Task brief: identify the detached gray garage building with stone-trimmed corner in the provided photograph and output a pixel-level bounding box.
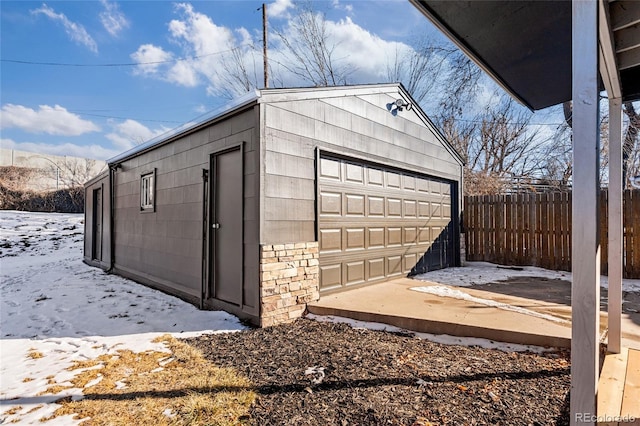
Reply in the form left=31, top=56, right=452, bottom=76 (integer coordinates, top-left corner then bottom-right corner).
left=84, top=84, right=462, bottom=326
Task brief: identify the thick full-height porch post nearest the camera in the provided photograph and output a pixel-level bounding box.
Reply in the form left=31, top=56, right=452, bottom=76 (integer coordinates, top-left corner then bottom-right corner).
left=570, top=0, right=600, bottom=425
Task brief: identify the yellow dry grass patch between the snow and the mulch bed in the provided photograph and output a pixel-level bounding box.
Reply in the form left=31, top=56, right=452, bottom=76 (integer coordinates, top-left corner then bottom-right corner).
left=42, top=336, right=256, bottom=426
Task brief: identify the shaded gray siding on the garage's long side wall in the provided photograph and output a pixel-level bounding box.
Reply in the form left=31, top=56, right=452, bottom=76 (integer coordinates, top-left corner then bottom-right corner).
left=115, top=107, right=259, bottom=317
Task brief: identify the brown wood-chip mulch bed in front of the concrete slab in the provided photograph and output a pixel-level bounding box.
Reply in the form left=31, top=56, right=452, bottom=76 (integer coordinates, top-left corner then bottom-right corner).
left=185, top=319, right=570, bottom=426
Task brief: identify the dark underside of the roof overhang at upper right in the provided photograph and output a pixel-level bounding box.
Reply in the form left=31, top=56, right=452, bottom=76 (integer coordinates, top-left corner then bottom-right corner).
left=409, top=0, right=640, bottom=110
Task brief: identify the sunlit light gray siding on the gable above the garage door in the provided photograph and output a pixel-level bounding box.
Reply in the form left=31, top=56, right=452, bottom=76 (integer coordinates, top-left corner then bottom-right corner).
left=261, top=89, right=462, bottom=244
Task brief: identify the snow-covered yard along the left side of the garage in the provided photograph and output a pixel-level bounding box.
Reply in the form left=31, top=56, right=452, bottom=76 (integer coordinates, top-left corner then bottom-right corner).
left=0, top=211, right=244, bottom=425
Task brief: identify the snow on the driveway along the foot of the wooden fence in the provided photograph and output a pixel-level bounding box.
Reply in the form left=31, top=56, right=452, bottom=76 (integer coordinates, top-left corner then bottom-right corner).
left=413, top=262, right=640, bottom=292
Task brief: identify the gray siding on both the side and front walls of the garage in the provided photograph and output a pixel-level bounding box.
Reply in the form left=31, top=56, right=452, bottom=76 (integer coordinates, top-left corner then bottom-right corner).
left=85, top=85, right=462, bottom=322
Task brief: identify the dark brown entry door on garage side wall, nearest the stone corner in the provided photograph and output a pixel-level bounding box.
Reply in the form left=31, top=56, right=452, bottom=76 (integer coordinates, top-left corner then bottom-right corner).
left=209, top=147, right=243, bottom=305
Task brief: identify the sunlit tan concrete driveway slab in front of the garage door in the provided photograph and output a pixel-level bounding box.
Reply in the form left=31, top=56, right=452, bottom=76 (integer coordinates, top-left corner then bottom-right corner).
left=308, top=277, right=640, bottom=349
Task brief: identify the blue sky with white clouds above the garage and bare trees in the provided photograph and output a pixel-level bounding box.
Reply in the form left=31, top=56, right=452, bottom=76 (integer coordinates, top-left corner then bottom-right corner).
left=0, top=0, right=437, bottom=159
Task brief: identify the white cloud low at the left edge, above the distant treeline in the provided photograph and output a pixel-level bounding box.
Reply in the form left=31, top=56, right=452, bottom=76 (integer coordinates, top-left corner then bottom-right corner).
left=0, top=104, right=100, bottom=136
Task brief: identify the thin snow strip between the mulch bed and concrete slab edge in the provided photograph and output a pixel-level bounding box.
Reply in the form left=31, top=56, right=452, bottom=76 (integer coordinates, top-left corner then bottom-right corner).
left=306, top=314, right=556, bottom=354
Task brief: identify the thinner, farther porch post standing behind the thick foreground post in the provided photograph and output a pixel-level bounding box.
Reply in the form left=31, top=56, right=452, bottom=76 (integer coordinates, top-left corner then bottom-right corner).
left=607, top=98, right=623, bottom=354
